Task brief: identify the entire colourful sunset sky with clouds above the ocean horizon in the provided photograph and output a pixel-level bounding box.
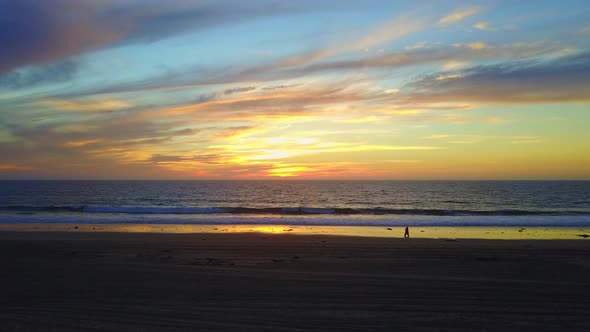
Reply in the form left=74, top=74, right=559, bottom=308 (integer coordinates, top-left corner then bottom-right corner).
left=0, top=0, right=590, bottom=179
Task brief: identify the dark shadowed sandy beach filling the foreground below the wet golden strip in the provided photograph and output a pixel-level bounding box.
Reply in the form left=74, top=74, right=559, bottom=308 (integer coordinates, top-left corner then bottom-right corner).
left=0, top=231, right=590, bottom=331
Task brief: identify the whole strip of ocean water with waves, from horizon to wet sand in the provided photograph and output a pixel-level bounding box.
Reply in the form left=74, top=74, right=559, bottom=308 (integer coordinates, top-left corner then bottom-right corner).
left=0, top=180, right=590, bottom=227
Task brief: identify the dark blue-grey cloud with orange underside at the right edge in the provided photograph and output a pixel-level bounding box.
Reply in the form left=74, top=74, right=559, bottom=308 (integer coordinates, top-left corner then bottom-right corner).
left=406, top=53, right=590, bottom=103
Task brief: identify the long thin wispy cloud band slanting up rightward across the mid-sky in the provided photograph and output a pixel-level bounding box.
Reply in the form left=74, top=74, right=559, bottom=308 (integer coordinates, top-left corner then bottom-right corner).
left=63, top=41, right=567, bottom=95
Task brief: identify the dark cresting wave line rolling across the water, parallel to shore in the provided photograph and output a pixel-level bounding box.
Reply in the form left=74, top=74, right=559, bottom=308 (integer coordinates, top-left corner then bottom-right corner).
left=0, top=205, right=590, bottom=216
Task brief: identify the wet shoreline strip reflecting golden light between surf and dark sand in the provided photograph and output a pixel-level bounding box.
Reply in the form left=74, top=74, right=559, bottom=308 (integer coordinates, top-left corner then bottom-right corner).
left=0, top=223, right=590, bottom=240
